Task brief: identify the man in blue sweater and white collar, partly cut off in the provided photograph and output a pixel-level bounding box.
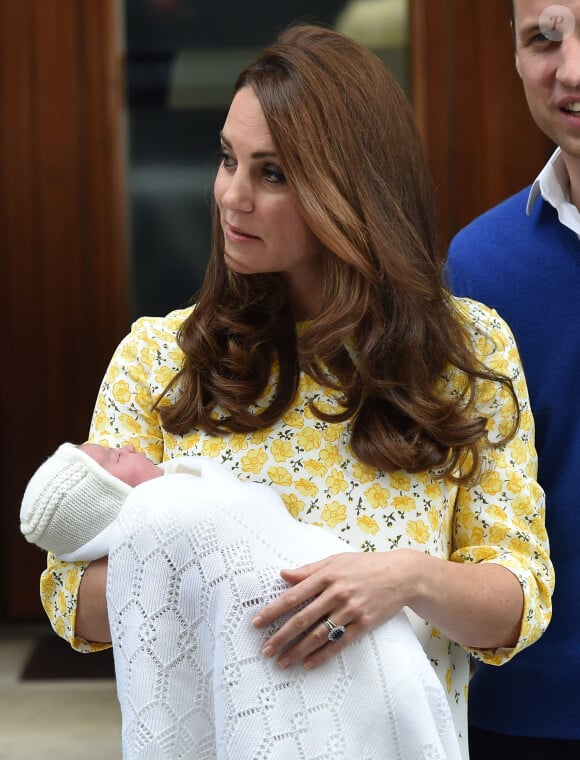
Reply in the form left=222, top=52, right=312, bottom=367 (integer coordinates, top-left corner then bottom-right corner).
left=448, top=0, right=580, bottom=760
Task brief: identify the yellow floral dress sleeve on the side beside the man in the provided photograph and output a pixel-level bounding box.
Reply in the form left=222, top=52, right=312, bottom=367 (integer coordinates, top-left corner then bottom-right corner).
left=451, top=302, right=554, bottom=665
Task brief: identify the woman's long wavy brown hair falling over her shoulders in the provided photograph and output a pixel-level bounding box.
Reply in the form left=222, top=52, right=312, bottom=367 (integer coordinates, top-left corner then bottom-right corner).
left=158, top=26, right=517, bottom=478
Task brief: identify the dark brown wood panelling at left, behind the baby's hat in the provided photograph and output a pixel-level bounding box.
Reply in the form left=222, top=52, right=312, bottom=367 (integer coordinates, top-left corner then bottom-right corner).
left=0, top=0, right=128, bottom=620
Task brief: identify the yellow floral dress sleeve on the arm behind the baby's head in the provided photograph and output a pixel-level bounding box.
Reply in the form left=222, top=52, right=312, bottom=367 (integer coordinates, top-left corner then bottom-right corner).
left=40, top=310, right=188, bottom=652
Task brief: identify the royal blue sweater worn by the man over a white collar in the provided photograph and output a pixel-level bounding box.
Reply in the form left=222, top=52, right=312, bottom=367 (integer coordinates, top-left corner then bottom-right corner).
left=447, top=188, right=580, bottom=739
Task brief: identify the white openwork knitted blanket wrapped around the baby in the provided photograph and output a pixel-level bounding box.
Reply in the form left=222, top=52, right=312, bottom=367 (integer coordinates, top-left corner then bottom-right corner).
left=107, top=460, right=460, bottom=760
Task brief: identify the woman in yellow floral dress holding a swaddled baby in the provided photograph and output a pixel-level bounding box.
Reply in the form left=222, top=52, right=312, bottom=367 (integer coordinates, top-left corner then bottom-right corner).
left=42, top=26, right=553, bottom=760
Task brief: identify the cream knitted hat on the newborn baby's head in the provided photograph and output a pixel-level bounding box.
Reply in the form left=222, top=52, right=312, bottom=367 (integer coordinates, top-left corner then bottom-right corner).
left=20, top=443, right=131, bottom=557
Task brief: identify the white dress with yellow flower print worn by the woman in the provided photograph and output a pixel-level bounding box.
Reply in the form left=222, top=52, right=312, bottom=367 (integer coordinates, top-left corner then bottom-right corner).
left=41, top=299, right=554, bottom=746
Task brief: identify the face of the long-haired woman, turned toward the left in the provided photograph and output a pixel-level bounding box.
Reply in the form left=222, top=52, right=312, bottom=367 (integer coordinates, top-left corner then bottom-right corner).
left=214, top=87, right=320, bottom=309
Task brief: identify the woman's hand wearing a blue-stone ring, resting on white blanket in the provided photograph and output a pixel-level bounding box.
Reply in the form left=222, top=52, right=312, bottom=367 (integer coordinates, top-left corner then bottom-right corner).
left=253, top=550, right=419, bottom=669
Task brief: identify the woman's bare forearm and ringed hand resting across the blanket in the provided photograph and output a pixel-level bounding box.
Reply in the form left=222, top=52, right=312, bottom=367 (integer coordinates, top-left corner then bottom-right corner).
left=253, top=549, right=523, bottom=669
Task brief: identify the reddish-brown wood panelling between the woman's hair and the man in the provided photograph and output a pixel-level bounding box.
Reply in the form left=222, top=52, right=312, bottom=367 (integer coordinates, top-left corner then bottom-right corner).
left=410, top=0, right=553, bottom=246
